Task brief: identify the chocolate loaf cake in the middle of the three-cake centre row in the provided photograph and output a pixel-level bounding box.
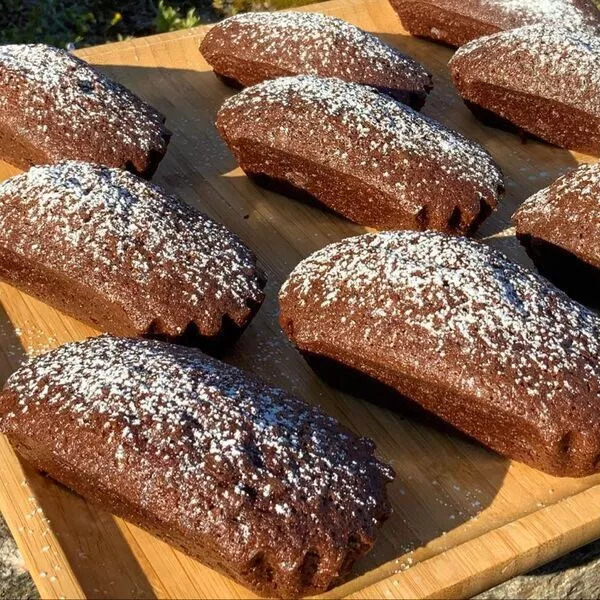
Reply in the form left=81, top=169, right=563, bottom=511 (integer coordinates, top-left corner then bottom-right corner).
left=217, top=75, right=503, bottom=233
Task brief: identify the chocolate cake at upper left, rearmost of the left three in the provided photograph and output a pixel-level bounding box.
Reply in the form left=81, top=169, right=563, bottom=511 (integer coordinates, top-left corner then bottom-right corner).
left=0, top=44, right=171, bottom=177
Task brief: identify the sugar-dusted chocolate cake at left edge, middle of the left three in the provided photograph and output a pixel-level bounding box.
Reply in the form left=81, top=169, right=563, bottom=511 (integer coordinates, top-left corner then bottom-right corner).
left=0, top=162, right=264, bottom=341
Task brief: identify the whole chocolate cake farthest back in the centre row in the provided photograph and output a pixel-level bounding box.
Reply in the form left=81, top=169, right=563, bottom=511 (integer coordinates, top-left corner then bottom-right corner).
left=200, top=11, right=433, bottom=110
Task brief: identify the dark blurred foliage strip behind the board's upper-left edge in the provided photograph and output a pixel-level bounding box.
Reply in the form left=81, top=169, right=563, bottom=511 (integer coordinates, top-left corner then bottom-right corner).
left=0, top=0, right=315, bottom=47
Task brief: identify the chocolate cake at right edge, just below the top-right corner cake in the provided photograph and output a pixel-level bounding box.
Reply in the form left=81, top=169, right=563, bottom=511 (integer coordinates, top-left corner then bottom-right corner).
left=450, top=25, right=600, bottom=154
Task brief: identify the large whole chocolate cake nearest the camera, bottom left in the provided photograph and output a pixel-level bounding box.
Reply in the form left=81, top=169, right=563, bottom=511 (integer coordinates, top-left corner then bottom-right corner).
left=0, top=336, right=393, bottom=598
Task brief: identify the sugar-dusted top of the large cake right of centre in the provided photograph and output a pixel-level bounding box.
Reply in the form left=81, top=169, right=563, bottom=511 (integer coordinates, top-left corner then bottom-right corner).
left=281, top=232, right=600, bottom=426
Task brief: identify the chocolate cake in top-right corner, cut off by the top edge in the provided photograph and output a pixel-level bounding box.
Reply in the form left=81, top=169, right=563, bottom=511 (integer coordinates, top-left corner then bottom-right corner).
left=390, top=0, right=600, bottom=46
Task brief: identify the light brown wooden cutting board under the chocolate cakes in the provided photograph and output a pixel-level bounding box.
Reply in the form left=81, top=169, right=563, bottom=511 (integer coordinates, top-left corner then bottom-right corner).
left=0, top=0, right=600, bottom=598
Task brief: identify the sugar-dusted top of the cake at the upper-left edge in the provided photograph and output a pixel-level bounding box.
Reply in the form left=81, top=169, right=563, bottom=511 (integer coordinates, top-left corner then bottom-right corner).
left=0, top=44, right=168, bottom=160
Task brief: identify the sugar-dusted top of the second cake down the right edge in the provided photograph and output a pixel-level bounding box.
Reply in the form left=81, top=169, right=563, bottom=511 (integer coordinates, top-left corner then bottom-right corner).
left=450, top=25, right=600, bottom=116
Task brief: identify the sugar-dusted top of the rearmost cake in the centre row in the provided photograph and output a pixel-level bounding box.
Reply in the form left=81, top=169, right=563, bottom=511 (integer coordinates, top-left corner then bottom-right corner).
left=209, top=11, right=431, bottom=88
